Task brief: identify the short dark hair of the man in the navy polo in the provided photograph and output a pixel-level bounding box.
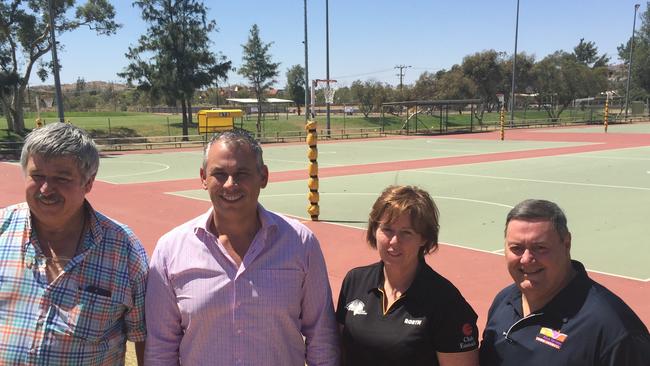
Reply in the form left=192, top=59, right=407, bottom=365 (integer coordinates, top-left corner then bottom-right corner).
left=506, top=199, right=570, bottom=240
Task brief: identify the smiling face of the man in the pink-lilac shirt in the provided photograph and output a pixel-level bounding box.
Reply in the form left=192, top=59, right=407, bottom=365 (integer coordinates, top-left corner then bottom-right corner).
left=201, top=141, right=269, bottom=224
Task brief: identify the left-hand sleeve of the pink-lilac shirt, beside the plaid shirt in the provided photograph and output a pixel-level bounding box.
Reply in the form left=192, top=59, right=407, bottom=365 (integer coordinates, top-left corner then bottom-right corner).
left=145, top=241, right=183, bottom=365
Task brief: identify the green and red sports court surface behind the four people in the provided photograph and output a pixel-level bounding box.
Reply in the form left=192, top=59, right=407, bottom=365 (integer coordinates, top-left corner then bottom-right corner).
left=0, top=123, right=650, bottom=329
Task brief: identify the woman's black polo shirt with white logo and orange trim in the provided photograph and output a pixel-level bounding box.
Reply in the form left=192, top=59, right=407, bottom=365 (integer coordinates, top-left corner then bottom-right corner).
left=336, top=260, right=478, bottom=366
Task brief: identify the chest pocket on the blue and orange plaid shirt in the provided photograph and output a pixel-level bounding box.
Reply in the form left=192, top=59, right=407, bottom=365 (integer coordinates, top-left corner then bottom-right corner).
left=55, top=289, right=120, bottom=342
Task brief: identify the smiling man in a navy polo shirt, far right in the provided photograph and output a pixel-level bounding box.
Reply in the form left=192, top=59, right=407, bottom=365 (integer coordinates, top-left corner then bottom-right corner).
left=480, top=200, right=650, bottom=366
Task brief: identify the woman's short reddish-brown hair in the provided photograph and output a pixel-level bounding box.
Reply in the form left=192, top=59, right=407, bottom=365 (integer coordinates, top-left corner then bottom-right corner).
left=366, top=186, right=440, bottom=256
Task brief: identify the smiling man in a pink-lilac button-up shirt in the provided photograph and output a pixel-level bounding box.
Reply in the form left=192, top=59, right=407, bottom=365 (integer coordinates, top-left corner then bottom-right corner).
left=145, top=130, right=339, bottom=366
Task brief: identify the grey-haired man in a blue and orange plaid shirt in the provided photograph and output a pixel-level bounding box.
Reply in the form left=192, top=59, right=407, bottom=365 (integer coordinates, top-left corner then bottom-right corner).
left=0, top=122, right=148, bottom=365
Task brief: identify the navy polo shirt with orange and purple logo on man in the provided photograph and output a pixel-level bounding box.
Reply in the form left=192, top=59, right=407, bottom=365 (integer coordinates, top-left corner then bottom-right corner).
left=480, top=261, right=650, bottom=366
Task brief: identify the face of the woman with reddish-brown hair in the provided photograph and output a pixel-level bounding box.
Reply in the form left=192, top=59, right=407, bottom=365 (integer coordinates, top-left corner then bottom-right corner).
left=375, top=212, right=425, bottom=269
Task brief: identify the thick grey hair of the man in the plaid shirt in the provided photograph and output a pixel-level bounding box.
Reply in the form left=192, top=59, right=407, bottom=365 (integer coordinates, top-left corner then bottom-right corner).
left=20, top=122, right=99, bottom=183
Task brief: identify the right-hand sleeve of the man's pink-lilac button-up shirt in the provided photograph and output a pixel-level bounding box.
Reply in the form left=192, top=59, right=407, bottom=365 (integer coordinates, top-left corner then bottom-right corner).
left=301, top=234, right=339, bottom=366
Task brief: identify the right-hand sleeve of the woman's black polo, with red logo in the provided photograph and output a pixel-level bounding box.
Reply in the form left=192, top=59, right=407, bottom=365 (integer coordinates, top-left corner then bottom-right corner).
left=432, top=288, right=478, bottom=353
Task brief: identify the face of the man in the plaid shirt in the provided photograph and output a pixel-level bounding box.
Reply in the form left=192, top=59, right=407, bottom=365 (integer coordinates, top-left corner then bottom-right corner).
left=25, top=154, right=94, bottom=228
